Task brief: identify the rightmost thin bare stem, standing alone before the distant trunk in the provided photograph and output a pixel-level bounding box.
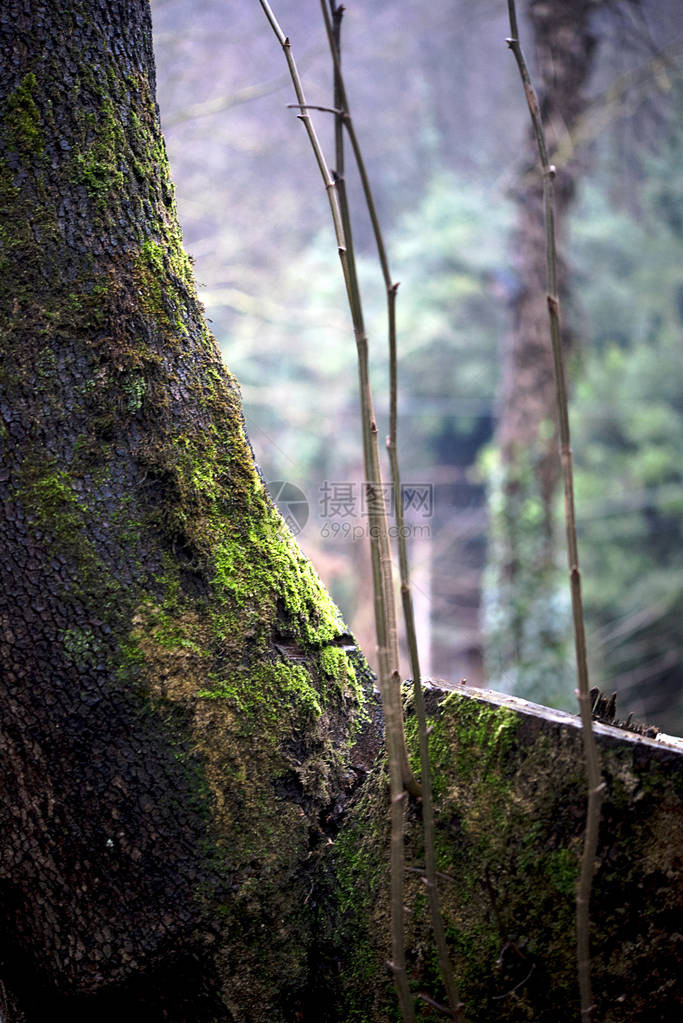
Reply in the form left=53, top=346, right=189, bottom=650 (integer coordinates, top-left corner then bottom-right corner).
left=506, top=0, right=604, bottom=1020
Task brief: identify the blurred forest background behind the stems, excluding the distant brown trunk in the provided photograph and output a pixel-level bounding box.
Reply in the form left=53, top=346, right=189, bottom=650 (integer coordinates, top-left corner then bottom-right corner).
left=152, top=0, right=683, bottom=732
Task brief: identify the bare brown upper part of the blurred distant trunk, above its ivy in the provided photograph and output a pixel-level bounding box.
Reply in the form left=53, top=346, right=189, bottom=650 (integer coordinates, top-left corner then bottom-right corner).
left=498, top=0, right=597, bottom=486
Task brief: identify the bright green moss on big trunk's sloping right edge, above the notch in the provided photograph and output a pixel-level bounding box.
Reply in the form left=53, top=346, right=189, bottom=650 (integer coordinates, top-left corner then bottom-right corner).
left=144, top=405, right=353, bottom=646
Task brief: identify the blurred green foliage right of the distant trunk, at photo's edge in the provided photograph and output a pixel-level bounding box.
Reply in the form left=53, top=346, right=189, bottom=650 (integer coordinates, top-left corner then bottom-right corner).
left=571, top=119, right=683, bottom=731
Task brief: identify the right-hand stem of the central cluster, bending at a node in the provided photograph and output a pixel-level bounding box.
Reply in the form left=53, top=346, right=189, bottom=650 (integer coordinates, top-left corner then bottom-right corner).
left=320, top=0, right=464, bottom=1021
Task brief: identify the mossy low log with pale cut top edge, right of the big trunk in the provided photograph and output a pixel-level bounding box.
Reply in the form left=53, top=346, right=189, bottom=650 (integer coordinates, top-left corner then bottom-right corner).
left=319, top=685, right=683, bottom=1023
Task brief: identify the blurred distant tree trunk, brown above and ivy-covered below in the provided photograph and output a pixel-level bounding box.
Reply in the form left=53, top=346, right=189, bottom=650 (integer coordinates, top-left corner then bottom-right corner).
left=488, top=0, right=598, bottom=702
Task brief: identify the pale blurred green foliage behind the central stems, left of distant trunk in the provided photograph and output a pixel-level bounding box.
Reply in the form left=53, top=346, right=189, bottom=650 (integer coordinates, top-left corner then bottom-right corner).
left=221, top=174, right=511, bottom=484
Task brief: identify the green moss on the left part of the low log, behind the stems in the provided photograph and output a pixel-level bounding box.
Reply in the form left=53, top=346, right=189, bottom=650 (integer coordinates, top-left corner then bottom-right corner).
left=327, top=693, right=573, bottom=1023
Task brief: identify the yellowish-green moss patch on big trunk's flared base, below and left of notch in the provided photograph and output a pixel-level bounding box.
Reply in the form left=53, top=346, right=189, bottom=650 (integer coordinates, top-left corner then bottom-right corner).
left=124, top=577, right=361, bottom=822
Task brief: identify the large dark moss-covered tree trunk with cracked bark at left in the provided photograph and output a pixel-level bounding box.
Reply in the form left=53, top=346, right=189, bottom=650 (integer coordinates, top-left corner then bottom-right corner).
left=0, top=0, right=376, bottom=1023
